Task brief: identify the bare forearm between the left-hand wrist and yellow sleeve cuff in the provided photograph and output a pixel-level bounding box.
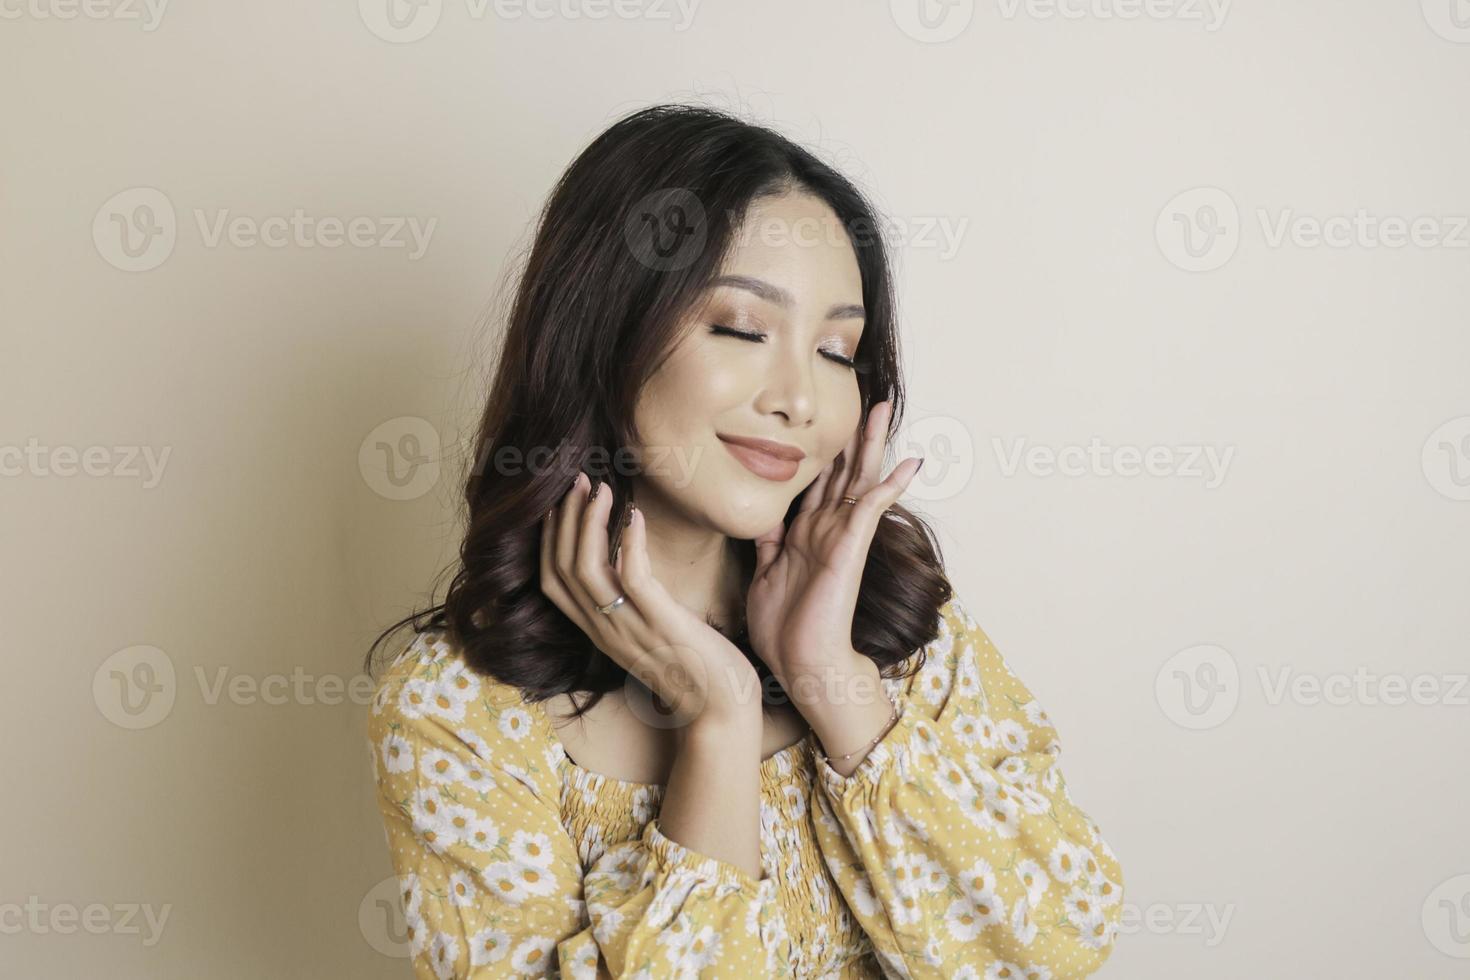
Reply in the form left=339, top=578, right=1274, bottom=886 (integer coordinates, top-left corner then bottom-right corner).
left=659, top=714, right=761, bottom=882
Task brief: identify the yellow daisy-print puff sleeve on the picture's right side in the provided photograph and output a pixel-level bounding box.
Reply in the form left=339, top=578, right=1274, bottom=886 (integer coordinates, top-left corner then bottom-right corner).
left=814, top=598, right=1123, bottom=980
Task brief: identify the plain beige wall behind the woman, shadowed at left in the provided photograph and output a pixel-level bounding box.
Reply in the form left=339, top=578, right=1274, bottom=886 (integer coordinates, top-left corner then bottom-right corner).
left=0, top=0, right=1470, bottom=980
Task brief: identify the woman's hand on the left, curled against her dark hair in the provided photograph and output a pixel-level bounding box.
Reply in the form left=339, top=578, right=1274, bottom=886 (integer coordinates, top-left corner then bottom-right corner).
left=541, top=472, right=761, bottom=729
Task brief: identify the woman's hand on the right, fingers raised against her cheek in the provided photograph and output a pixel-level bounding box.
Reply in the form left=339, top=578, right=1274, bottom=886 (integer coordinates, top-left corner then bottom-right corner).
left=745, top=401, right=923, bottom=696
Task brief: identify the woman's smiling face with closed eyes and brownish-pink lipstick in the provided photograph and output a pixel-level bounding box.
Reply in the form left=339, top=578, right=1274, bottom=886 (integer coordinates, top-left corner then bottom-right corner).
left=635, top=194, right=864, bottom=539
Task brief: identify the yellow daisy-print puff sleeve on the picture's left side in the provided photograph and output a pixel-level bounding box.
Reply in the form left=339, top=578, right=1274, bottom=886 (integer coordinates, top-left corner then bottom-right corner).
left=368, top=633, right=781, bottom=980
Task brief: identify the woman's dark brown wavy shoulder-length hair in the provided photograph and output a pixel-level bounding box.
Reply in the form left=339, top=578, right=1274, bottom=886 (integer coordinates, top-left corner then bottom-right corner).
left=363, top=104, right=953, bottom=714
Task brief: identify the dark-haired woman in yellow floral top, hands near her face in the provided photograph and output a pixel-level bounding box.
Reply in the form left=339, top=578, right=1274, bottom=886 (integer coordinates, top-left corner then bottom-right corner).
left=369, top=106, right=1123, bottom=980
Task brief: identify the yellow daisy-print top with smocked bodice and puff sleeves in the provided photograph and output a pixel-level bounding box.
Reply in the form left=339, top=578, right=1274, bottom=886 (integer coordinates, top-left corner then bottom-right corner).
left=368, top=597, right=1123, bottom=980
